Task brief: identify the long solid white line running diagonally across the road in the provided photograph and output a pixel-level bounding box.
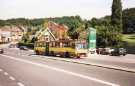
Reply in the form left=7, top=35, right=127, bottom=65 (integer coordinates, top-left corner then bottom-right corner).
left=1, top=55, right=120, bottom=86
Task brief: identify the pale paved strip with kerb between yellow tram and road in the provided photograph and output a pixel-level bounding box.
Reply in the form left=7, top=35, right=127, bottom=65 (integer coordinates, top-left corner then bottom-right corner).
left=30, top=54, right=135, bottom=73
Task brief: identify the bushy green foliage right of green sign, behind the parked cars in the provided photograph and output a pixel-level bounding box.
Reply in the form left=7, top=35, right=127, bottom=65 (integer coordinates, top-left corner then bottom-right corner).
left=96, top=25, right=122, bottom=47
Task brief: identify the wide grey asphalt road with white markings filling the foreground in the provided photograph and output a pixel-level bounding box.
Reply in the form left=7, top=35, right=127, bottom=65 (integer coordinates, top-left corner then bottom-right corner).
left=0, top=49, right=135, bottom=86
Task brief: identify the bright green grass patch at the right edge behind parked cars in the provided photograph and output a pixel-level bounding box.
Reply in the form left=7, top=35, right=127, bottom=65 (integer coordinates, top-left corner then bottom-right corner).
left=123, top=34, right=135, bottom=46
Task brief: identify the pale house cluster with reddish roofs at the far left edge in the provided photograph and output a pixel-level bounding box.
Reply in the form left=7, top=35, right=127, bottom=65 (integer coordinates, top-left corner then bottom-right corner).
left=0, top=26, right=24, bottom=44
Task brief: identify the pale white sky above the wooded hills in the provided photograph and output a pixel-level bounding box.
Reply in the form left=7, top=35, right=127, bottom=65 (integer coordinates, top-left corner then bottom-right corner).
left=0, top=0, right=135, bottom=19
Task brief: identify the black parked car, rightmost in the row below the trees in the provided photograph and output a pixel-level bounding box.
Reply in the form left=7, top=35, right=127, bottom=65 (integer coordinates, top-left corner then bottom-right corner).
left=110, top=48, right=127, bottom=56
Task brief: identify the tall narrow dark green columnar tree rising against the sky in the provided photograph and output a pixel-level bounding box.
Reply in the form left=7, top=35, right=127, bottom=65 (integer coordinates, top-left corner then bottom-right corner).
left=111, top=0, right=122, bottom=32
